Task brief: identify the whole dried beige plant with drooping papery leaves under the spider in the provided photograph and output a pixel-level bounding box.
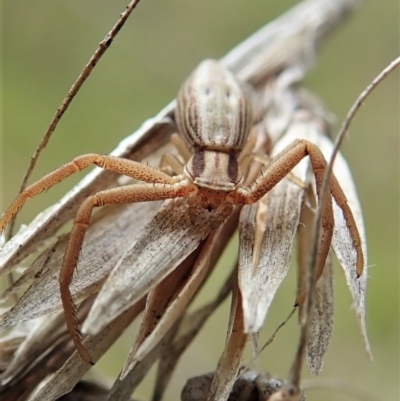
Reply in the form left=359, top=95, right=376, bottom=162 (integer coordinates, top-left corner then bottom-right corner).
left=0, top=0, right=396, bottom=401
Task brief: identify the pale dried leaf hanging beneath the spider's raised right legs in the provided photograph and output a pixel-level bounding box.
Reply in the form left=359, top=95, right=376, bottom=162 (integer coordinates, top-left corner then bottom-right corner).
left=239, top=120, right=310, bottom=333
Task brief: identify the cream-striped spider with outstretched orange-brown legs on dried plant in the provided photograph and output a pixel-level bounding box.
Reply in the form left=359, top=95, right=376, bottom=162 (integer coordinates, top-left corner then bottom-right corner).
left=0, top=60, right=364, bottom=363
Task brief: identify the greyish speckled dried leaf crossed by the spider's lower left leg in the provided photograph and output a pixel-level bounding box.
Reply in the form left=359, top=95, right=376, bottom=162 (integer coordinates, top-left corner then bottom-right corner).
left=0, top=203, right=157, bottom=330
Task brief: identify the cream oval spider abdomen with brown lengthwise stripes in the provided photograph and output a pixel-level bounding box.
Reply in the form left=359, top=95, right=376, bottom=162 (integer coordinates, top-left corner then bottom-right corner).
left=175, top=60, right=251, bottom=155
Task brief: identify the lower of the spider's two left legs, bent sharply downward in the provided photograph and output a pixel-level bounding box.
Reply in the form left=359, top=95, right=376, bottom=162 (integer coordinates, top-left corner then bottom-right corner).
left=60, top=179, right=193, bottom=364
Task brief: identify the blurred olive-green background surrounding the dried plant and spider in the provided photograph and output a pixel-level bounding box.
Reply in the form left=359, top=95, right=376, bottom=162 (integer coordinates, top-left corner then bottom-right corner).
left=0, top=0, right=399, bottom=401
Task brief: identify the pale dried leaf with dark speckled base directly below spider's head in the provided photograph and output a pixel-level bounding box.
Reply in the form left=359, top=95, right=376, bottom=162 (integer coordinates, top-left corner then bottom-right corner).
left=83, top=200, right=212, bottom=334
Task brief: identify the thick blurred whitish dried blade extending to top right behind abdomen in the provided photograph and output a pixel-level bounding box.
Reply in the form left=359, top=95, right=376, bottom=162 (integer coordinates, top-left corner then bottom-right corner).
left=222, top=0, right=361, bottom=86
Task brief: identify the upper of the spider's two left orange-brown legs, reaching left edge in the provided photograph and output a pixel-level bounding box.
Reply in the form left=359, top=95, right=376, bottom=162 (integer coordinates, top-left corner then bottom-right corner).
left=0, top=154, right=178, bottom=233
